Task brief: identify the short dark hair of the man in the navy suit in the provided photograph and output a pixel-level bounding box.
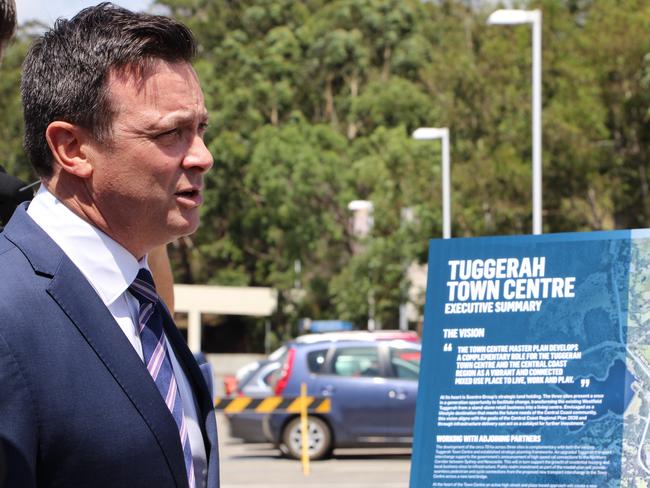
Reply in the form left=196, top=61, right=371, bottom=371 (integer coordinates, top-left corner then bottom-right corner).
left=21, top=2, right=196, bottom=177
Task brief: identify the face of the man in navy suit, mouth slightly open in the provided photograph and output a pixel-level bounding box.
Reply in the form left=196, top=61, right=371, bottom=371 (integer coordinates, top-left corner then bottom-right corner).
left=89, top=61, right=212, bottom=257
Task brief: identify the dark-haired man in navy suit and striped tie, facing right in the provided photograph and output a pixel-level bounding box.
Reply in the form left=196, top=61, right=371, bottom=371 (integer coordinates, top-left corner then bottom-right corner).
left=0, top=0, right=219, bottom=488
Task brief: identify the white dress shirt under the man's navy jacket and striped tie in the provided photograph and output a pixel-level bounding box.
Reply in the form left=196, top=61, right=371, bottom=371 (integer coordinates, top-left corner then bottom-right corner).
left=27, top=186, right=207, bottom=487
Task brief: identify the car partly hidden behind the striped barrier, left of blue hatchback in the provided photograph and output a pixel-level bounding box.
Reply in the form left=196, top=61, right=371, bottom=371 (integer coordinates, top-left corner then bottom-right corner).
left=226, top=360, right=280, bottom=442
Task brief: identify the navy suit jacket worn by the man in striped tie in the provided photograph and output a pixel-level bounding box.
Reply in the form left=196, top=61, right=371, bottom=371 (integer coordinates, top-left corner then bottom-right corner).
left=0, top=205, right=219, bottom=488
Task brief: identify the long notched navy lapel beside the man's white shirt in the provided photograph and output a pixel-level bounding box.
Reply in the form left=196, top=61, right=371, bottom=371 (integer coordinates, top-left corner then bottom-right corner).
left=5, top=208, right=187, bottom=486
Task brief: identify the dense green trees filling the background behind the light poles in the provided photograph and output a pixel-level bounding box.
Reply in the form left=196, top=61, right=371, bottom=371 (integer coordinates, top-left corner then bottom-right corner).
left=0, top=0, right=650, bottom=336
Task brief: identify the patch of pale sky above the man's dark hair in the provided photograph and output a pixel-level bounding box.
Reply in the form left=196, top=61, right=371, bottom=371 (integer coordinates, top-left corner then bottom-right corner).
left=16, top=0, right=153, bottom=25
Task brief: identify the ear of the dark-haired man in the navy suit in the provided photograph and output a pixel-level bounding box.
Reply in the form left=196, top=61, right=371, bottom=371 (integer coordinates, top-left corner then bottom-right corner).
left=45, top=120, right=93, bottom=178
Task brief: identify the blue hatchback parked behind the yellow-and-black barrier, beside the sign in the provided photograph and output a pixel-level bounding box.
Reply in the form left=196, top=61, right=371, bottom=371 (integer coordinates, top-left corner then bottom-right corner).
left=264, top=331, right=421, bottom=459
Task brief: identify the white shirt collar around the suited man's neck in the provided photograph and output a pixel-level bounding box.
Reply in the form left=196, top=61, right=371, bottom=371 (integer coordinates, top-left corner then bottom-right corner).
left=27, top=185, right=147, bottom=306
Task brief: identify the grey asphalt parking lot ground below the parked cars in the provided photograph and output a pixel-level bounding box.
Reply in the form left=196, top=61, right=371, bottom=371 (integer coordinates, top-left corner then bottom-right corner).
left=217, top=414, right=411, bottom=488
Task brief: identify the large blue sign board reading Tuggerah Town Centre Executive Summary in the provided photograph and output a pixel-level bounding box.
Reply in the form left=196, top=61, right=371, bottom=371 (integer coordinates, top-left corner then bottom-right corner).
left=410, top=231, right=650, bottom=488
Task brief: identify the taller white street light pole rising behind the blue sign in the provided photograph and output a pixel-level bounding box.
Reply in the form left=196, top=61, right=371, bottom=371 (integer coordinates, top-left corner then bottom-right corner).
left=487, top=9, right=542, bottom=234
